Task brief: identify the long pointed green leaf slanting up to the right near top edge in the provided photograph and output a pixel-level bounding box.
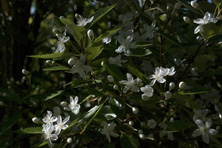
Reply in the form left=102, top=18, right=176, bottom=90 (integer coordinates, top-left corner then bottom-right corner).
left=87, top=5, right=116, bottom=28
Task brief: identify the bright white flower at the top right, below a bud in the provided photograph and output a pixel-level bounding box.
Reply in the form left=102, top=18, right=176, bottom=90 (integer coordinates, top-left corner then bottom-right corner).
left=193, top=12, right=217, bottom=34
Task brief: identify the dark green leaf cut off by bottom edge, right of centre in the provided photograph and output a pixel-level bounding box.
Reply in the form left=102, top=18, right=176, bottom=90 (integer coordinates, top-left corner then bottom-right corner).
left=120, top=134, right=138, bottom=148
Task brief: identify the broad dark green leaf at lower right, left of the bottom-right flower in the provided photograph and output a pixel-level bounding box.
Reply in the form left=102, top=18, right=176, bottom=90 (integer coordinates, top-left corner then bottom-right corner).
left=165, top=120, right=190, bottom=132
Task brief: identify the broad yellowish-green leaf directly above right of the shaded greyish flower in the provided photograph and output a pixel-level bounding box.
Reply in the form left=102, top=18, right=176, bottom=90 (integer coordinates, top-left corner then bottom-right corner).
left=85, top=43, right=104, bottom=61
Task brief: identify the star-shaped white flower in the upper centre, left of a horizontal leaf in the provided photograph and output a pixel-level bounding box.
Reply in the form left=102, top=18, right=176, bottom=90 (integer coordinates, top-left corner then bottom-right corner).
left=115, top=35, right=134, bottom=56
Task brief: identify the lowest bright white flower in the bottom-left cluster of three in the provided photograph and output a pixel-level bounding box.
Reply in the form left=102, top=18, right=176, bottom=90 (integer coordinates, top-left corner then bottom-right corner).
left=42, top=123, right=59, bottom=148
